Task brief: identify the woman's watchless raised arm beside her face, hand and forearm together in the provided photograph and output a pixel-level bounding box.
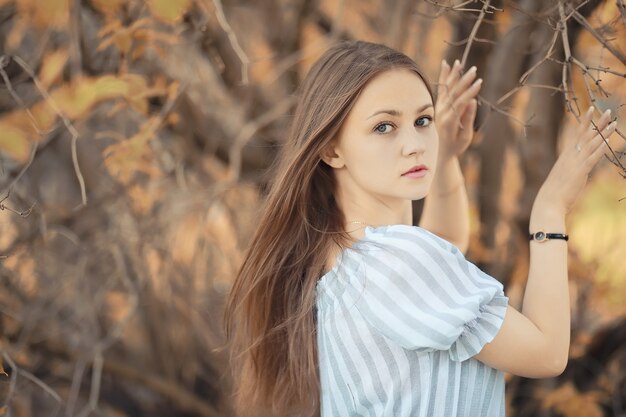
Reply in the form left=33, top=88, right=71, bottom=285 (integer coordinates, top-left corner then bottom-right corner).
left=420, top=60, right=482, bottom=252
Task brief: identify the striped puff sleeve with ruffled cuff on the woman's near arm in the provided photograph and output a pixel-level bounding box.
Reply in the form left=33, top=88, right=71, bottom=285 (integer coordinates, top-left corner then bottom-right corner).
left=355, top=225, right=508, bottom=361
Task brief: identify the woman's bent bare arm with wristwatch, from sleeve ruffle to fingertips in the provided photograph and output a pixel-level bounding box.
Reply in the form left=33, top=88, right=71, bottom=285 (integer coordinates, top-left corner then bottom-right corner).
left=475, top=105, right=616, bottom=378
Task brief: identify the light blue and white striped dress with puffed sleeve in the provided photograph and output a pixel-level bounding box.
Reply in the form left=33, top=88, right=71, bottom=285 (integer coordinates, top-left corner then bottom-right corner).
left=316, top=224, right=508, bottom=417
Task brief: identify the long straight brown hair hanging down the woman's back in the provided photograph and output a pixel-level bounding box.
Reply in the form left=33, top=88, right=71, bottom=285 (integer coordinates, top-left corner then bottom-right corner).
left=224, top=41, right=432, bottom=416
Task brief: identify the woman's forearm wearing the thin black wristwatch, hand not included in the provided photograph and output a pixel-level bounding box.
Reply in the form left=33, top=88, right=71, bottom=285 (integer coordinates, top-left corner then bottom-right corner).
left=521, top=203, right=570, bottom=366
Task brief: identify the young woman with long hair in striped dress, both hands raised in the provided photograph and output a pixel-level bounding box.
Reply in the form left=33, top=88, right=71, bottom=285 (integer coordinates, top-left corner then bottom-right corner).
left=225, top=42, right=615, bottom=417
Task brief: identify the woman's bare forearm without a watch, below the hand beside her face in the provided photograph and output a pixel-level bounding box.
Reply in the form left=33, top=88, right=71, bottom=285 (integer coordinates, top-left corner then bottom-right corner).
left=420, top=157, right=469, bottom=252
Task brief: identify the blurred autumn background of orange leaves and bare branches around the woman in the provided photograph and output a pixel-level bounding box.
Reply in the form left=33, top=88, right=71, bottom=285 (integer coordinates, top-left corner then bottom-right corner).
left=0, top=0, right=626, bottom=417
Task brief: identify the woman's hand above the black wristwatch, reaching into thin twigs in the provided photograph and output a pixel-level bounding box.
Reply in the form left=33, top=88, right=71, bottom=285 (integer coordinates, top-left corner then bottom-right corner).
left=535, top=107, right=617, bottom=214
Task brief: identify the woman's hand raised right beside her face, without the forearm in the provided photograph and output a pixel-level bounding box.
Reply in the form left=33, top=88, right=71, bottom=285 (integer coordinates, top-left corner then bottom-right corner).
left=435, top=60, right=482, bottom=160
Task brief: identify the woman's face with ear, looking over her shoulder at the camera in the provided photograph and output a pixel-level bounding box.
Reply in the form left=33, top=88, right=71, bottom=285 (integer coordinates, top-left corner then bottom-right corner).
left=324, top=69, right=439, bottom=208
